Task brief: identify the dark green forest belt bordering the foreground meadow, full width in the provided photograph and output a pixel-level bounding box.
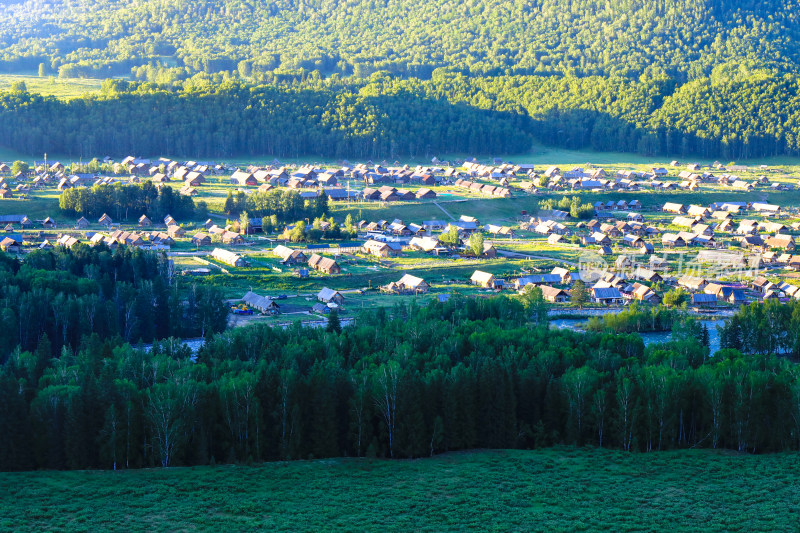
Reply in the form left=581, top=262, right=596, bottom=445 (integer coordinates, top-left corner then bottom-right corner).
left=0, top=278, right=800, bottom=469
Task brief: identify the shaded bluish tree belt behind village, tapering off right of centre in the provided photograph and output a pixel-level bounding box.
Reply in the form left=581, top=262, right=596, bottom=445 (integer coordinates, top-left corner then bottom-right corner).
left=0, top=81, right=531, bottom=160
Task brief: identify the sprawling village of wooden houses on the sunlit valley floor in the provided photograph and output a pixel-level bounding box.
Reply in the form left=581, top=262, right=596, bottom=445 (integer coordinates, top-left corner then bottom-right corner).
left=0, top=157, right=800, bottom=324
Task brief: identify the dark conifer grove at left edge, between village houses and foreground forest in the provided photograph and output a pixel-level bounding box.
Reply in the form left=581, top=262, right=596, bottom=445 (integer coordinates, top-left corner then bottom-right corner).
left=0, top=244, right=228, bottom=362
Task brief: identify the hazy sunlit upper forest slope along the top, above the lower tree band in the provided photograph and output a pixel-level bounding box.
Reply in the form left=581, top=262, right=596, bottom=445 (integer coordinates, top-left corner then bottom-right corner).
left=0, top=0, right=800, bottom=81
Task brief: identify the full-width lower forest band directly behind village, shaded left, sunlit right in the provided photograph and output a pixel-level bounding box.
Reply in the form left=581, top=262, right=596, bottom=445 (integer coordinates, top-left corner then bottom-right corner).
left=0, top=70, right=800, bottom=160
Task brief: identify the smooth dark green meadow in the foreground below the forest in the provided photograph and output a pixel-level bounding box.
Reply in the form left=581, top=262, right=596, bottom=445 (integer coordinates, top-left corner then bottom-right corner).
left=0, top=448, right=800, bottom=531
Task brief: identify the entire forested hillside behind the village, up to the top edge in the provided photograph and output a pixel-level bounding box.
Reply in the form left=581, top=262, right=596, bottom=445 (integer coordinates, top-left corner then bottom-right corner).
left=0, top=0, right=800, bottom=160
